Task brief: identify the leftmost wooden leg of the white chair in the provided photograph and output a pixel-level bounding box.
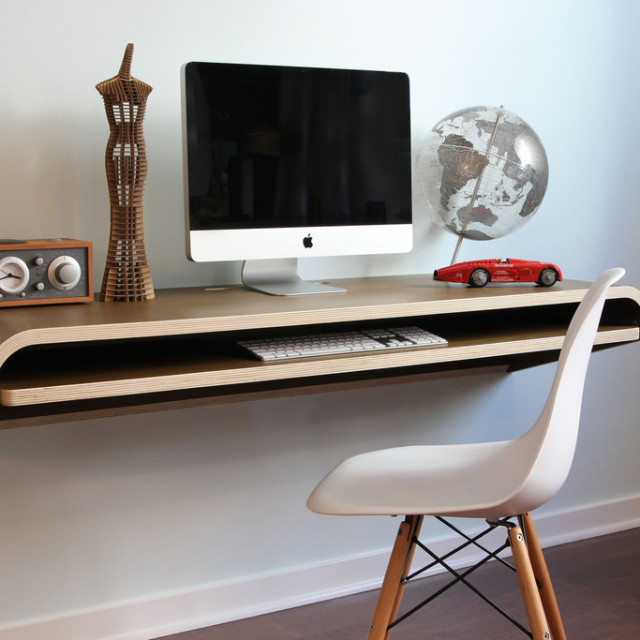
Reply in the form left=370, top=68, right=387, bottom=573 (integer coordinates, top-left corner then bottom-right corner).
left=368, top=516, right=423, bottom=640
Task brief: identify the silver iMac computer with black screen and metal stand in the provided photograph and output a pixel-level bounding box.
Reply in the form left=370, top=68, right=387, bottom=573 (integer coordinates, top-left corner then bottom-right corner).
left=182, top=62, right=412, bottom=295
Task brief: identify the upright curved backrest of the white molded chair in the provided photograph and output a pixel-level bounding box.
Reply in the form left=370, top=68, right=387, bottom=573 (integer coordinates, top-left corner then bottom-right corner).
left=505, top=268, right=624, bottom=515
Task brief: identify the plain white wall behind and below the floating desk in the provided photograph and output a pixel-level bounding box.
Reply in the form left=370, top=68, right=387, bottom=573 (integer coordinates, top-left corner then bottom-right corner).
left=0, top=0, right=640, bottom=640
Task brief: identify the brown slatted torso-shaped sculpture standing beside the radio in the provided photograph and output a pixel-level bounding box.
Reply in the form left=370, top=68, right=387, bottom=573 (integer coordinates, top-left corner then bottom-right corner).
left=96, top=44, right=155, bottom=302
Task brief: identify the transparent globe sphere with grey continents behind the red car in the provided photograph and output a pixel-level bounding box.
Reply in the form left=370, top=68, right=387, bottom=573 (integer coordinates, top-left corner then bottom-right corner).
left=415, top=106, right=549, bottom=240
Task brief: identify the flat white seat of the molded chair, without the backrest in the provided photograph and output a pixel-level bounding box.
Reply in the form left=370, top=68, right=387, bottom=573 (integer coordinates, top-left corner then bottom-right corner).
left=307, top=436, right=538, bottom=518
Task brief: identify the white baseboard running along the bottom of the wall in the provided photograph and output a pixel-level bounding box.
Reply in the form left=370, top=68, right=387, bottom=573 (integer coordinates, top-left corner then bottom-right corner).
left=0, top=496, right=640, bottom=640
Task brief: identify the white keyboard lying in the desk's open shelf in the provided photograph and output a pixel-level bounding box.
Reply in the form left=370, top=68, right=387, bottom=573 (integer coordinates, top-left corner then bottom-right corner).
left=238, top=327, right=447, bottom=362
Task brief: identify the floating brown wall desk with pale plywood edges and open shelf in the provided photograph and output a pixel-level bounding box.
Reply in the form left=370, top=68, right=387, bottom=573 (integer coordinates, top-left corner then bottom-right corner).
left=0, top=275, right=640, bottom=427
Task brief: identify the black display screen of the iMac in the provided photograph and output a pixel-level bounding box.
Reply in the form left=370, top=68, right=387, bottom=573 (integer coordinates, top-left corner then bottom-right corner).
left=184, top=62, right=411, bottom=230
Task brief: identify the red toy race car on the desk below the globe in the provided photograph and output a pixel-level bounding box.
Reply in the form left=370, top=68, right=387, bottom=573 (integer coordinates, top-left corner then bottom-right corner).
left=433, top=258, right=562, bottom=287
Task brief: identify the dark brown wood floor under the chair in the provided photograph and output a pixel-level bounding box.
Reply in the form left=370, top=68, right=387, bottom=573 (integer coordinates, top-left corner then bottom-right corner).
left=156, top=528, right=640, bottom=640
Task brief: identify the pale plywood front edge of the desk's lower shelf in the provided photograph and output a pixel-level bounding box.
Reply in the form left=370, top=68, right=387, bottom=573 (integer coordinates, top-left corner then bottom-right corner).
left=0, top=327, right=639, bottom=406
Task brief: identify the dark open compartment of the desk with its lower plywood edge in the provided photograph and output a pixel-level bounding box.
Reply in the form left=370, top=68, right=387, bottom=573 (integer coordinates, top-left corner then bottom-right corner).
left=0, top=304, right=638, bottom=406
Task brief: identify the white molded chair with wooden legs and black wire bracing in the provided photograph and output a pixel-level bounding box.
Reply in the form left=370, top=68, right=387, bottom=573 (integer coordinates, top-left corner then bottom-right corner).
left=307, top=269, right=624, bottom=640
